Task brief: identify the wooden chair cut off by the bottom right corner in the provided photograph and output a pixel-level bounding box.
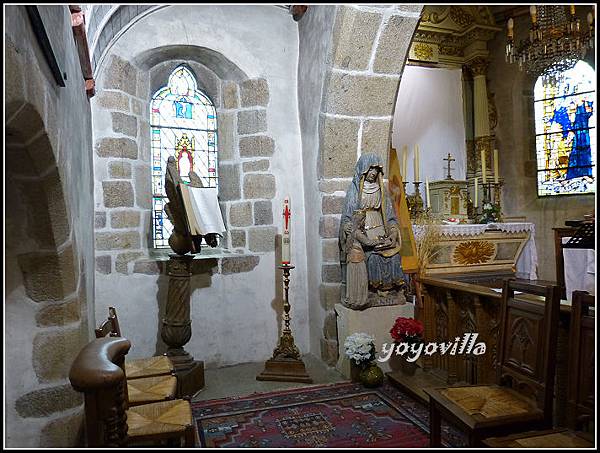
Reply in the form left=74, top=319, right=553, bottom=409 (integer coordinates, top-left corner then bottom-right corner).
left=483, top=291, right=596, bottom=448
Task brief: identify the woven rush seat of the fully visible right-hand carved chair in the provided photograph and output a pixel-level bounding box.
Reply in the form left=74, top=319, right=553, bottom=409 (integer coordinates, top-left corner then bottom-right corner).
left=440, top=385, right=535, bottom=418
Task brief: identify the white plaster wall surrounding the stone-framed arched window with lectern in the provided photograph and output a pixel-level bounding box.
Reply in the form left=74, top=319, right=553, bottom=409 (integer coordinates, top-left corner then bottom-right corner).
left=94, top=5, right=308, bottom=366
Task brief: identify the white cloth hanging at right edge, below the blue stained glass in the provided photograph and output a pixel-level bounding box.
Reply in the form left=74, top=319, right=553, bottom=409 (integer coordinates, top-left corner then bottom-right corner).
left=562, top=237, right=596, bottom=300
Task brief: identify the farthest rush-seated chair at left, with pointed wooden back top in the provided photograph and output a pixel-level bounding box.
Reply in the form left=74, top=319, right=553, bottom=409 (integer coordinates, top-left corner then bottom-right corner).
left=96, top=307, right=174, bottom=380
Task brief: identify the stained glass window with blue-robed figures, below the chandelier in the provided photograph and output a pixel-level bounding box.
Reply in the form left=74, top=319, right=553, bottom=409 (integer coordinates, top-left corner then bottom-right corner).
left=534, top=61, right=596, bottom=197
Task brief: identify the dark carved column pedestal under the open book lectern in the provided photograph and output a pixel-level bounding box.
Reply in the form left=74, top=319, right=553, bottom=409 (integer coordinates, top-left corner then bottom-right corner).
left=161, top=255, right=204, bottom=398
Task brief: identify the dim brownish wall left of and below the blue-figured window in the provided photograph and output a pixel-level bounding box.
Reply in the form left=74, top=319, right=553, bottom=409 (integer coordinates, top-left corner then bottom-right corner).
left=488, top=12, right=596, bottom=280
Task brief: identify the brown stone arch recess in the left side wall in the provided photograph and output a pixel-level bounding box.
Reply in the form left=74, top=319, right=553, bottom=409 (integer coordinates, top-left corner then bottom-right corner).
left=5, top=101, right=85, bottom=447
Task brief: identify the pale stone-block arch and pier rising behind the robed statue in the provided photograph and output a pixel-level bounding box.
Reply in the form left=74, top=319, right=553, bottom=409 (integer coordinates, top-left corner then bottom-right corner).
left=300, top=5, right=422, bottom=366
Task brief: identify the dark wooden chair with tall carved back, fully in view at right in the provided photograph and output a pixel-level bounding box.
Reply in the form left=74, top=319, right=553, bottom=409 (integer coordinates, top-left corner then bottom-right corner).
left=424, top=279, right=560, bottom=447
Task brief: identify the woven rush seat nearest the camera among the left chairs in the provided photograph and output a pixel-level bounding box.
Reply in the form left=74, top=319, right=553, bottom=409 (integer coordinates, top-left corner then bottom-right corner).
left=127, top=400, right=193, bottom=440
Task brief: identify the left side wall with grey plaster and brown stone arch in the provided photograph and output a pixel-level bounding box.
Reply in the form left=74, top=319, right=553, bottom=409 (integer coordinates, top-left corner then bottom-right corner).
left=4, top=6, right=94, bottom=448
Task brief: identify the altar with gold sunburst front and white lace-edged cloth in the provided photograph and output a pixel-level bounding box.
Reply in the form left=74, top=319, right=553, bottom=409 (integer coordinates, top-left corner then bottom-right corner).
left=413, top=222, right=538, bottom=280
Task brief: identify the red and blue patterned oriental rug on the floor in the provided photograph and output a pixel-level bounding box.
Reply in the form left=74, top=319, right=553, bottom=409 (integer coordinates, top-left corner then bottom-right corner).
left=192, top=382, right=466, bottom=448
